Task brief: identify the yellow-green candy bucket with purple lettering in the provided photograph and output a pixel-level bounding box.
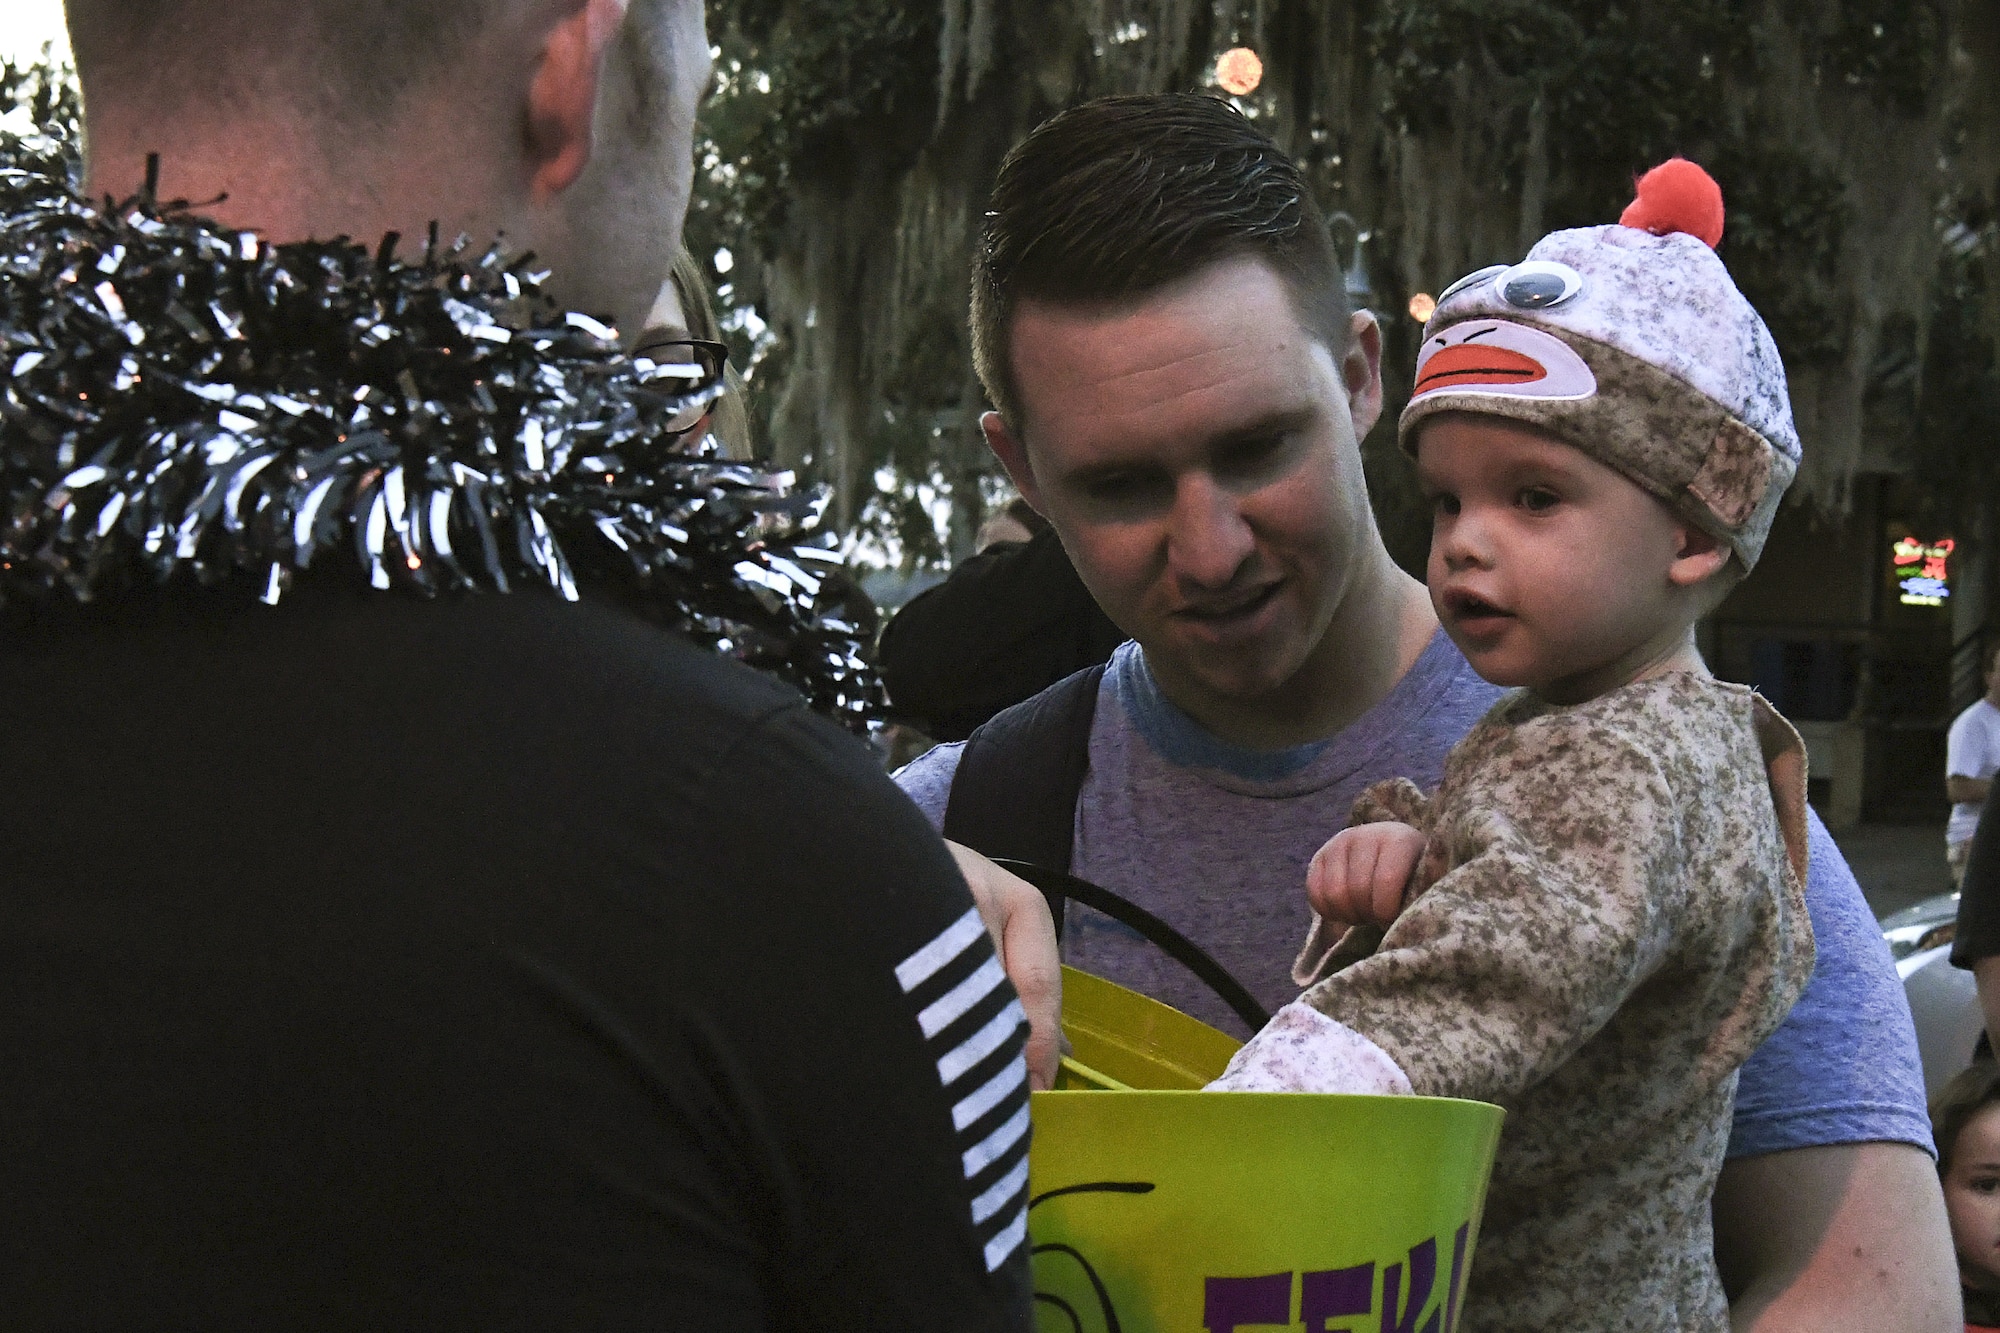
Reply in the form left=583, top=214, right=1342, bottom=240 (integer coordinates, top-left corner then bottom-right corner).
left=1028, top=969, right=1502, bottom=1333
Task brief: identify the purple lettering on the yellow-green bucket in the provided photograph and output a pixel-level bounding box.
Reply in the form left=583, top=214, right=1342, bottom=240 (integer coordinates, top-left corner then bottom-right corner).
left=1202, top=1223, right=1472, bottom=1333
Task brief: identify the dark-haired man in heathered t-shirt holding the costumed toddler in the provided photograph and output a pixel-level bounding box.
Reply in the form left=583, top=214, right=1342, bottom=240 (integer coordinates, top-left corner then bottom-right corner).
left=916, top=96, right=1954, bottom=1329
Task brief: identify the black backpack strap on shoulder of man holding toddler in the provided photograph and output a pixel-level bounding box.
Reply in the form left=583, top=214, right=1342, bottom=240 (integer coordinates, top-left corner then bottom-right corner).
left=944, top=662, right=1104, bottom=933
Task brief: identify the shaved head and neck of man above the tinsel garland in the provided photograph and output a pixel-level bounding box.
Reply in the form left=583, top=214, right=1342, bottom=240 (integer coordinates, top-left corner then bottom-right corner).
left=68, top=0, right=710, bottom=342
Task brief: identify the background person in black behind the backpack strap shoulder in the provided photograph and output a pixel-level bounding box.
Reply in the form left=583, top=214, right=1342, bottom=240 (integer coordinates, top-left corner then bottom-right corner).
left=878, top=496, right=1124, bottom=741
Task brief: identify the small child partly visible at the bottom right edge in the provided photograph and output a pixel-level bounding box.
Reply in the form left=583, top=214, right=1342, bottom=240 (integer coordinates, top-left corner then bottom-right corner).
left=1930, top=1061, right=2000, bottom=1333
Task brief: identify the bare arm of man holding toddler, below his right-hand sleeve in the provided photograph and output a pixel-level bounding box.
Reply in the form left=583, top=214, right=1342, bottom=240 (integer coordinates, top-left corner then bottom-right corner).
left=1714, top=1143, right=1964, bottom=1333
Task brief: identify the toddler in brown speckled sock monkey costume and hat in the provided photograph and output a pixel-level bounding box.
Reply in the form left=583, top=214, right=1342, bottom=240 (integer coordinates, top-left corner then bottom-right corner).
left=1214, top=160, right=1812, bottom=1333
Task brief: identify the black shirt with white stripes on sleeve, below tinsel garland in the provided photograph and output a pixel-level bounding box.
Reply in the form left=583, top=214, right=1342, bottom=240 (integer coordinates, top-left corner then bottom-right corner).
left=0, top=586, right=1030, bottom=1333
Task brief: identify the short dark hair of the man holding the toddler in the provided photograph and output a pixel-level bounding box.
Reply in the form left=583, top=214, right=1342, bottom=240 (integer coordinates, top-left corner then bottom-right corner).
left=972, top=92, right=1350, bottom=430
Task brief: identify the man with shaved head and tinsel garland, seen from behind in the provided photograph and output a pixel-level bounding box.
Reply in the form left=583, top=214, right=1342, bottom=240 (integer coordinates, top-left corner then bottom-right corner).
left=0, top=0, right=1056, bottom=1333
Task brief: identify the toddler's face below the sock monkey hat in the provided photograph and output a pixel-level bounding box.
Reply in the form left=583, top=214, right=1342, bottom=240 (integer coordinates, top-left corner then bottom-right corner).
left=1416, top=412, right=1690, bottom=703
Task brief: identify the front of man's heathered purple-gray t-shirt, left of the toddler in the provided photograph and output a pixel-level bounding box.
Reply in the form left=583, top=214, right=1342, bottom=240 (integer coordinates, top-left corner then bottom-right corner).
left=896, top=632, right=1500, bottom=1037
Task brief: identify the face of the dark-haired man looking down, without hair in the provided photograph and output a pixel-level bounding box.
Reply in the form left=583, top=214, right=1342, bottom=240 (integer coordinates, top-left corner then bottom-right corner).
left=986, top=258, right=1380, bottom=713
